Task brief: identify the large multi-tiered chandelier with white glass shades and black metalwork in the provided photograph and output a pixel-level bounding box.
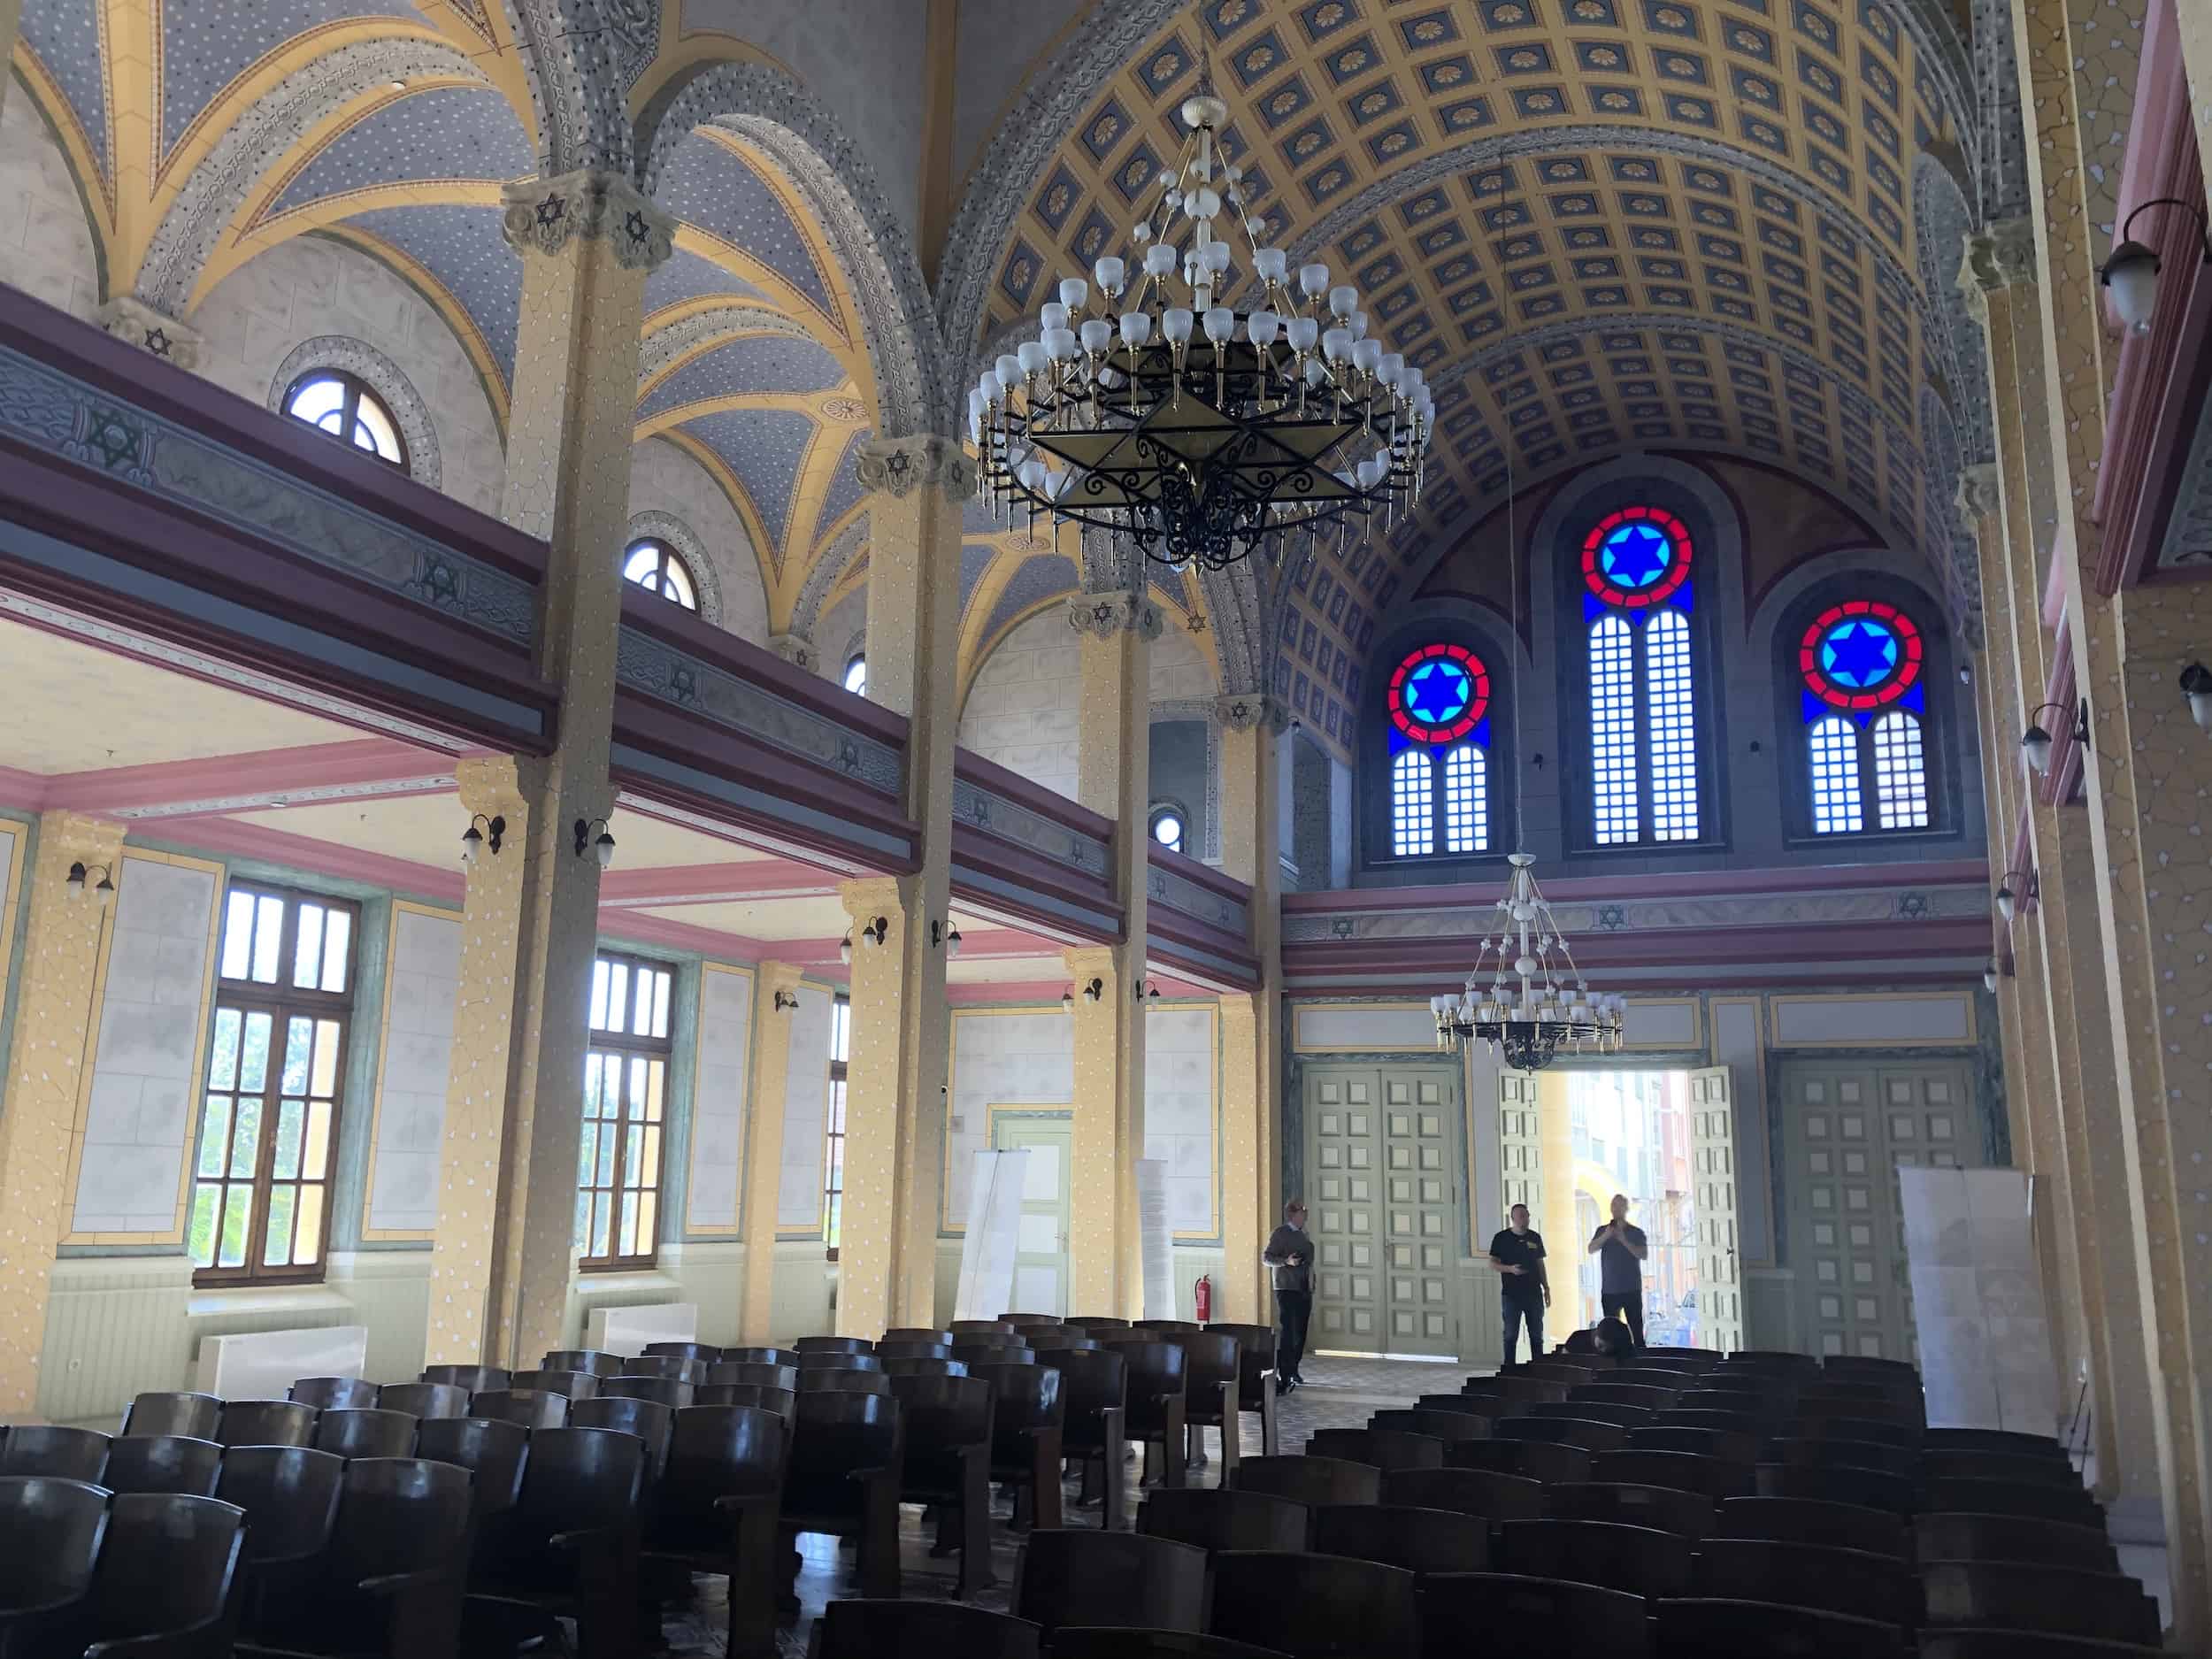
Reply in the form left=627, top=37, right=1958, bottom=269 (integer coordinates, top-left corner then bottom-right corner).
left=969, top=43, right=1436, bottom=571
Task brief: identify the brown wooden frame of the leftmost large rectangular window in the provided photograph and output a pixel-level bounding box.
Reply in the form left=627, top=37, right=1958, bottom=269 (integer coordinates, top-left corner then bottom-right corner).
left=186, top=880, right=361, bottom=1290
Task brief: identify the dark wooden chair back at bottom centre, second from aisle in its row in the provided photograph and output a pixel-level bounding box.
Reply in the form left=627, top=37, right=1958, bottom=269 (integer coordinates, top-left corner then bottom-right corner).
left=1212, top=1551, right=1420, bottom=1659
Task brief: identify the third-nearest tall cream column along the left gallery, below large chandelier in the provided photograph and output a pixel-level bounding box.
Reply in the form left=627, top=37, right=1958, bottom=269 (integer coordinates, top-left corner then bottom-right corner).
left=1066, top=591, right=1159, bottom=1318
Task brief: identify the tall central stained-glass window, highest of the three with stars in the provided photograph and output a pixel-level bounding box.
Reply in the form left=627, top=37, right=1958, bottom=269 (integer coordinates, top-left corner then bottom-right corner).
left=1582, top=507, right=1706, bottom=848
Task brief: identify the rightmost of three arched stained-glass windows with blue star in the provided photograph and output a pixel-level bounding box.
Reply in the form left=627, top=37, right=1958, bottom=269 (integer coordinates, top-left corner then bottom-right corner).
left=1796, top=600, right=1933, bottom=836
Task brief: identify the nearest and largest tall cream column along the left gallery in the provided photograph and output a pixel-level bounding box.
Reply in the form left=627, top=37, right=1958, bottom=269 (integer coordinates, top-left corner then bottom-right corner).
left=429, top=173, right=675, bottom=1365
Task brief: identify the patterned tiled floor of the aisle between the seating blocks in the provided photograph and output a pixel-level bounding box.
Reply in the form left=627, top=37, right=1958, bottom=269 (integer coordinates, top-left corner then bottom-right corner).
left=664, top=1356, right=1467, bottom=1659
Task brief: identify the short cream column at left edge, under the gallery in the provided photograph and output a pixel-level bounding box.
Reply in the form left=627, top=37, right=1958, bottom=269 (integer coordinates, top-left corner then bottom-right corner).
left=0, top=812, right=124, bottom=1418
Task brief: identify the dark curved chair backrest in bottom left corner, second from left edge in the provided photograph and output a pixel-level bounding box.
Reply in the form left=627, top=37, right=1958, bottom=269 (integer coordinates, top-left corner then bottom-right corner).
left=87, top=1494, right=246, bottom=1655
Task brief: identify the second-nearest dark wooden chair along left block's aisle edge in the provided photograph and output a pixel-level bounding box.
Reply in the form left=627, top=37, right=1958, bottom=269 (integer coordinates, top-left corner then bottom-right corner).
left=779, top=1398, right=905, bottom=1597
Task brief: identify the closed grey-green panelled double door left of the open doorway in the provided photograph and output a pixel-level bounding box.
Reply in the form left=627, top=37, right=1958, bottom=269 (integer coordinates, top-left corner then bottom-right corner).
left=1305, top=1064, right=1464, bottom=1354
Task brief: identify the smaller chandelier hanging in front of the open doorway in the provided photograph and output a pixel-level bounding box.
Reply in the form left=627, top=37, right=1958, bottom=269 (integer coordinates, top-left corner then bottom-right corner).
left=1429, top=852, right=1624, bottom=1071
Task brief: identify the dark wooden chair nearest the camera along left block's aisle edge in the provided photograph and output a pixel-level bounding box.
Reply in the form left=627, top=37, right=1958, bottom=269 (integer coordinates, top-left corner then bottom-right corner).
left=646, top=1405, right=790, bottom=1659
